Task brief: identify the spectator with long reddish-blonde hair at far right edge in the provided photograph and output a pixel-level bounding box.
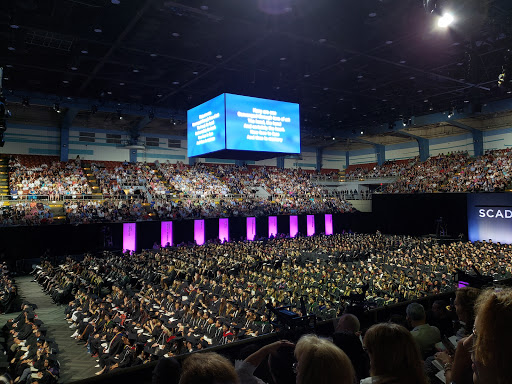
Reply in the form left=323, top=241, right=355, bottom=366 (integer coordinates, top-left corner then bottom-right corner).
left=466, top=288, right=512, bottom=384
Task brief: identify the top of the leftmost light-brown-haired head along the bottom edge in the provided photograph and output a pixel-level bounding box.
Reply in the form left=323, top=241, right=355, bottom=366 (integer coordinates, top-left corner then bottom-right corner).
left=180, top=352, right=239, bottom=384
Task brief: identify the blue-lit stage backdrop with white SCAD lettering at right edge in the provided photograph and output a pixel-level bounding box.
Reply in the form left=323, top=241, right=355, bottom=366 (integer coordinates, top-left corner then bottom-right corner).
left=468, top=193, right=512, bottom=244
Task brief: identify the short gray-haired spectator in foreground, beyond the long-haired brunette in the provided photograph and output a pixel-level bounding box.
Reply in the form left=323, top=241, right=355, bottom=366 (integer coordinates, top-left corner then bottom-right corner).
left=405, top=303, right=441, bottom=358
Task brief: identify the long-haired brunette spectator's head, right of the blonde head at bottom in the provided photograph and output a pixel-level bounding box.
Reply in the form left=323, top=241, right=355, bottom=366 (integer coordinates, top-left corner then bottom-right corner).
left=361, top=323, right=428, bottom=384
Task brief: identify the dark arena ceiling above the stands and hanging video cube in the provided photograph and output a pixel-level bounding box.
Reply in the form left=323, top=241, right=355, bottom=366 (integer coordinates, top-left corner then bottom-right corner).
left=0, top=0, right=512, bottom=150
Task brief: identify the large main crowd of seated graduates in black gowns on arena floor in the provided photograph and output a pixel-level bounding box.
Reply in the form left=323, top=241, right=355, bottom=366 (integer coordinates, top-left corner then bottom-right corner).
left=27, top=234, right=512, bottom=373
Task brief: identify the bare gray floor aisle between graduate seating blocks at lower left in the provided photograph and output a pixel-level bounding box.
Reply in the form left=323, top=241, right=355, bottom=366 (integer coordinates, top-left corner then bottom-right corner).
left=9, top=276, right=99, bottom=384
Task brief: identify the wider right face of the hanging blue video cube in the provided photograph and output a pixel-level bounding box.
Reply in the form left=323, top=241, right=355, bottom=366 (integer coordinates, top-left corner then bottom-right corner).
left=226, top=93, right=300, bottom=153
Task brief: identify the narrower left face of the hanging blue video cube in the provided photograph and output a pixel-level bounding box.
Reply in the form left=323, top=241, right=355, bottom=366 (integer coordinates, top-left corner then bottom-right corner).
left=187, top=94, right=226, bottom=157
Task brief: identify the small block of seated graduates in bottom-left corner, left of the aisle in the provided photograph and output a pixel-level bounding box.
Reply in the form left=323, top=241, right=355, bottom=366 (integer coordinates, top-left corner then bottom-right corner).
left=2, top=302, right=59, bottom=384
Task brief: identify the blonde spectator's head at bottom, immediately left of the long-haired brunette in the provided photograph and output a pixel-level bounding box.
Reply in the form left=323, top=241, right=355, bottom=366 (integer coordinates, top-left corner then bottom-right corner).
left=295, top=335, right=355, bottom=384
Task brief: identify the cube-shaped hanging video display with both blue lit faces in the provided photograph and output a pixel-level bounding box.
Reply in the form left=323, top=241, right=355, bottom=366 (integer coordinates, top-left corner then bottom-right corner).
left=187, top=93, right=300, bottom=157
